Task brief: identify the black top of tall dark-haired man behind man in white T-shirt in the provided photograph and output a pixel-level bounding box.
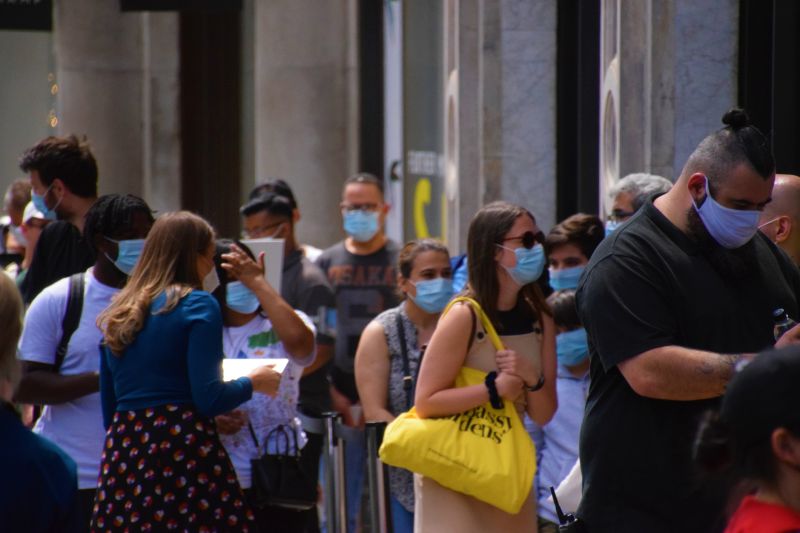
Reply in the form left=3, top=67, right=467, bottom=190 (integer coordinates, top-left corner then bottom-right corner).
left=20, top=220, right=95, bottom=303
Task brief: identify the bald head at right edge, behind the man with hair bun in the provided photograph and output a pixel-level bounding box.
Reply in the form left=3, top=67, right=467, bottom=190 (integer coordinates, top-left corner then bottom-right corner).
left=759, top=174, right=800, bottom=264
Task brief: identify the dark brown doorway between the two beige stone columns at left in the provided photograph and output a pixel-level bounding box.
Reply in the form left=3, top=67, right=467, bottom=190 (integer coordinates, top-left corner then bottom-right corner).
left=180, top=10, right=242, bottom=237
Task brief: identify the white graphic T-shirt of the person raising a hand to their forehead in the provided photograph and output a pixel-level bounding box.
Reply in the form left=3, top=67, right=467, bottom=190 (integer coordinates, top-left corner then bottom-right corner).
left=220, top=311, right=316, bottom=489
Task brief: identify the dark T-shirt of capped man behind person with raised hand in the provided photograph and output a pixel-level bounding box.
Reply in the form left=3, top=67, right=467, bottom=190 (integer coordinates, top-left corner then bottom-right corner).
left=281, top=250, right=336, bottom=416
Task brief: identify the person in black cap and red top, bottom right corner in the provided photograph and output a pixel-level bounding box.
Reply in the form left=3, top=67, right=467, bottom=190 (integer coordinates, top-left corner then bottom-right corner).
left=695, top=346, right=800, bottom=533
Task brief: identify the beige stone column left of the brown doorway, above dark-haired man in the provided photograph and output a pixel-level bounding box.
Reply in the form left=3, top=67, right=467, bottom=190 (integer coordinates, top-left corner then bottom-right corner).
left=53, top=0, right=180, bottom=210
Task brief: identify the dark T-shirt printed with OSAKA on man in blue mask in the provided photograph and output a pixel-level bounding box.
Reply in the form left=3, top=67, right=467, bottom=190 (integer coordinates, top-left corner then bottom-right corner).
left=317, top=240, right=400, bottom=400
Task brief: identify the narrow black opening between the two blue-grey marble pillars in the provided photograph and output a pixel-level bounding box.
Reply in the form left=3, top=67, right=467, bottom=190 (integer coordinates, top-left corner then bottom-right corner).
left=556, top=0, right=600, bottom=220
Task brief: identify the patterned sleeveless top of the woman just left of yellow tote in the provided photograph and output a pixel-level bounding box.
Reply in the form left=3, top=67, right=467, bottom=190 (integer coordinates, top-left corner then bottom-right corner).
left=375, top=303, right=420, bottom=513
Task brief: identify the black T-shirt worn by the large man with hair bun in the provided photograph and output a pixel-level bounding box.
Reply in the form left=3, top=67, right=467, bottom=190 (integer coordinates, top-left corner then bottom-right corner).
left=577, top=202, right=800, bottom=533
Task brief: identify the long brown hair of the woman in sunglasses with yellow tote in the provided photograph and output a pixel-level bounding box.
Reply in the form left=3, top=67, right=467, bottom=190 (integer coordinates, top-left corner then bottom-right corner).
left=466, top=202, right=551, bottom=324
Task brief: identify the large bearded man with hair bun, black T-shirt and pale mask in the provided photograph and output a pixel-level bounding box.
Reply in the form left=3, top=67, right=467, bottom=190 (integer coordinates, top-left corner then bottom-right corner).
left=577, top=109, right=800, bottom=533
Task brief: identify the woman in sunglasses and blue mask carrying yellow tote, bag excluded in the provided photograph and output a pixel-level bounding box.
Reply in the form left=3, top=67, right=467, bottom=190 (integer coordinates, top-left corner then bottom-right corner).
left=415, top=202, right=557, bottom=533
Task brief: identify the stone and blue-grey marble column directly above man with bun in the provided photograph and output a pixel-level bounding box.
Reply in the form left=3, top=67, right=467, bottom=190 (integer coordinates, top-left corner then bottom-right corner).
left=604, top=0, right=739, bottom=180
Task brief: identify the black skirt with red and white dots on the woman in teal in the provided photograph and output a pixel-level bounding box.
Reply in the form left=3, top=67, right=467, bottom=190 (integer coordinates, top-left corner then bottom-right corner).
left=91, top=405, right=256, bottom=532
